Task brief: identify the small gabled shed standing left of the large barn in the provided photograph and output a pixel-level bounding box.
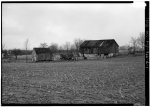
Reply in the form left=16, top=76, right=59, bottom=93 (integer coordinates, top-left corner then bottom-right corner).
left=32, top=48, right=52, bottom=62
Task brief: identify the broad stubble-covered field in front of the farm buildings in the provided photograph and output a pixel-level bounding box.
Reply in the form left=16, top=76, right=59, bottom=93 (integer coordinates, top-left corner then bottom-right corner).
left=2, top=56, right=145, bottom=105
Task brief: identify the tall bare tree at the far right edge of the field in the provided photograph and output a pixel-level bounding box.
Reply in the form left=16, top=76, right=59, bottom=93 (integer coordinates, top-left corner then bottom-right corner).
left=137, top=32, right=145, bottom=51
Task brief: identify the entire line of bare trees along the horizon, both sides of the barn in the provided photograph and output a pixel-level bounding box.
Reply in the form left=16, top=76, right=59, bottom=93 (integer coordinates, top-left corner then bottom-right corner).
left=2, top=32, right=145, bottom=61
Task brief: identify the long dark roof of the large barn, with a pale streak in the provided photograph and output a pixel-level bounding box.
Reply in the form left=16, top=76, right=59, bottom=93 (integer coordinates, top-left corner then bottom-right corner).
left=80, top=39, right=119, bottom=48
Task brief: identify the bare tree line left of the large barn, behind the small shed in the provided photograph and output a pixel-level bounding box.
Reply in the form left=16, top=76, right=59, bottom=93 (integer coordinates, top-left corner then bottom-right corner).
left=2, top=38, right=83, bottom=61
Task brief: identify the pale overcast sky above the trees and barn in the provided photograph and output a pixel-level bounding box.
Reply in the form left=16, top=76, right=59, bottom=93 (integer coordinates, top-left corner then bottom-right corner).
left=2, top=3, right=145, bottom=49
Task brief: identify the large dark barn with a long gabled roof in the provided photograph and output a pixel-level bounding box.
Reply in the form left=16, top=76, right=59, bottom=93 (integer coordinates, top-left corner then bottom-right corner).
left=80, top=39, right=119, bottom=56
